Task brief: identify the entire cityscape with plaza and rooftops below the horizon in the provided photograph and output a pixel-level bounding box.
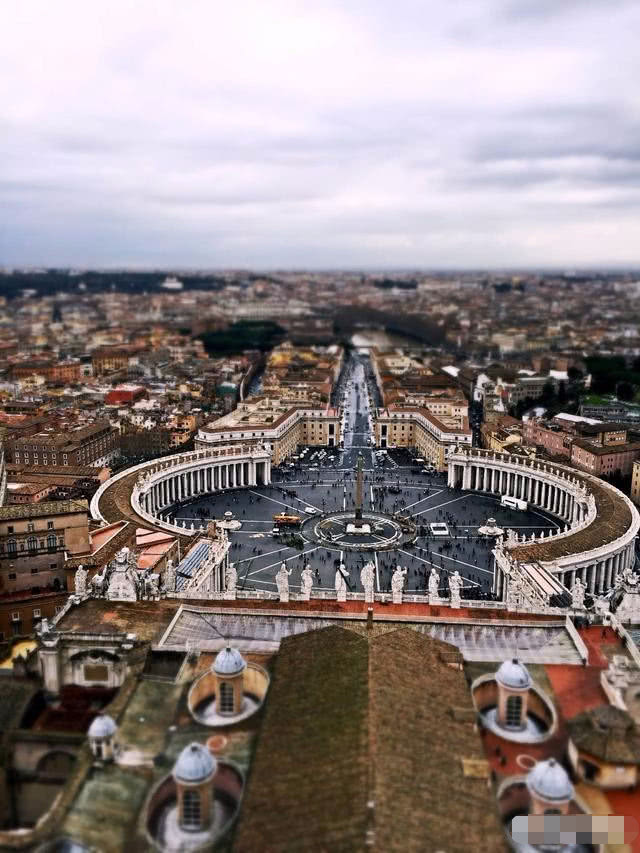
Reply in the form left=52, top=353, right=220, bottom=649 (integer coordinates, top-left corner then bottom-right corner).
left=0, top=269, right=640, bottom=851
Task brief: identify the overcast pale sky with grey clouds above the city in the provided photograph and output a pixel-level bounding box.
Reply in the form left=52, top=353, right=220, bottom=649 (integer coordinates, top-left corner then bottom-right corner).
left=0, top=0, right=640, bottom=268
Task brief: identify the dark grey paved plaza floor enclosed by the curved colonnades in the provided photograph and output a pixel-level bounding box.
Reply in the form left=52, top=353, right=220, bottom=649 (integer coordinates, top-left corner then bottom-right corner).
left=166, top=462, right=558, bottom=597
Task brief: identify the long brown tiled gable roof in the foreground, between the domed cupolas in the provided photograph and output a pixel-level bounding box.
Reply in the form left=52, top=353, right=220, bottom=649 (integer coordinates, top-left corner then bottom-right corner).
left=233, top=627, right=507, bottom=853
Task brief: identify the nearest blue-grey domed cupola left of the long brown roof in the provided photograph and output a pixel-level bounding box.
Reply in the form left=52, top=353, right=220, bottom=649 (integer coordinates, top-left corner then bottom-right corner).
left=173, top=742, right=218, bottom=832
